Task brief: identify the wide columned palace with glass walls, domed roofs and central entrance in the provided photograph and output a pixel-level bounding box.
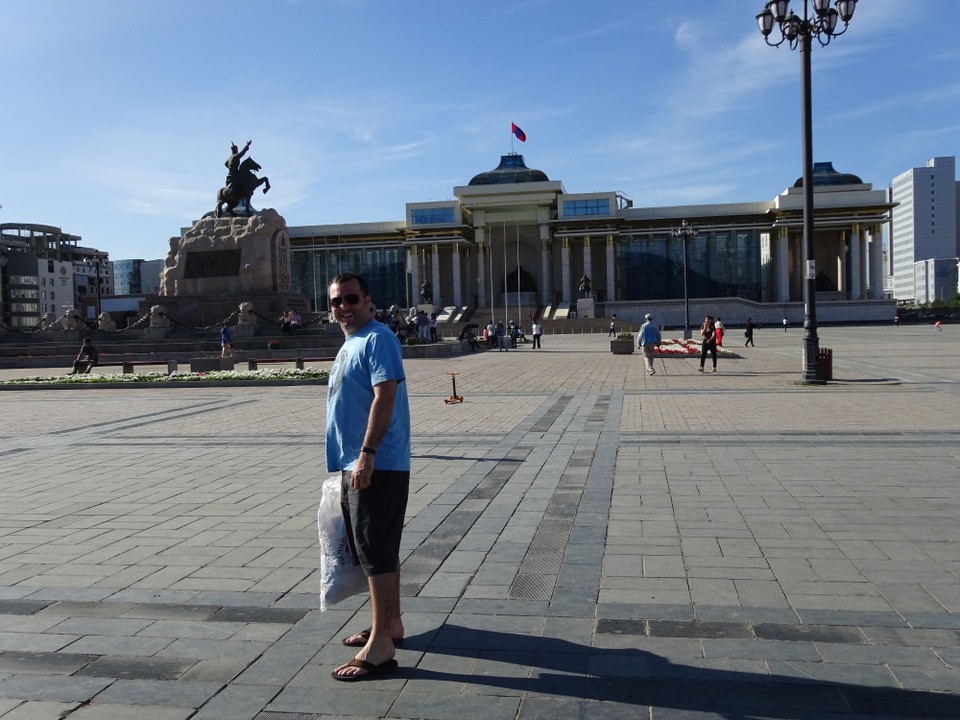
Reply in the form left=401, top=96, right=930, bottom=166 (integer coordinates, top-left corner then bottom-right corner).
left=289, top=153, right=896, bottom=326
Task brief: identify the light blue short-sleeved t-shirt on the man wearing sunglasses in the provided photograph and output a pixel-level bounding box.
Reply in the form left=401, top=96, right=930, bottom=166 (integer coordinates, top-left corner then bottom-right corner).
left=326, top=320, right=410, bottom=472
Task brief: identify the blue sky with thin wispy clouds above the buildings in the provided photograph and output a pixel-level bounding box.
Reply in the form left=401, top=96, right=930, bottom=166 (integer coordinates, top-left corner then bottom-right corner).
left=0, top=0, right=960, bottom=259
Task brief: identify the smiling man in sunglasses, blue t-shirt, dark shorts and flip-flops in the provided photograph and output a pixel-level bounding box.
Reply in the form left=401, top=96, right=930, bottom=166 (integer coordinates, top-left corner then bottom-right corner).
left=326, top=273, right=410, bottom=682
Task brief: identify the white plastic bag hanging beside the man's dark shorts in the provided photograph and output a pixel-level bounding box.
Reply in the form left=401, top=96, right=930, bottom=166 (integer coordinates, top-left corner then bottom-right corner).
left=317, top=475, right=368, bottom=611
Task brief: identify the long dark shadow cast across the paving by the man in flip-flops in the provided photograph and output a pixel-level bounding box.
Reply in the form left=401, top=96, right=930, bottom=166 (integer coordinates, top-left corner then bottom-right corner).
left=404, top=624, right=960, bottom=720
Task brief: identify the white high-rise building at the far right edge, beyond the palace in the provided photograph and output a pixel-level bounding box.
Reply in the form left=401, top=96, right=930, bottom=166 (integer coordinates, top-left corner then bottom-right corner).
left=888, top=157, right=960, bottom=303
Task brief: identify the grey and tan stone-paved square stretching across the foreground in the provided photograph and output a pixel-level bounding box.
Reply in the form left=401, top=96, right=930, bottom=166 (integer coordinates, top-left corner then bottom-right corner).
left=0, top=326, right=960, bottom=720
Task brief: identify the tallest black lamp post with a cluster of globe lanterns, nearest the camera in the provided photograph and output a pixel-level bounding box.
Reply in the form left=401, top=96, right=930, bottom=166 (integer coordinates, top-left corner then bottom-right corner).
left=757, top=0, right=857, bottom=384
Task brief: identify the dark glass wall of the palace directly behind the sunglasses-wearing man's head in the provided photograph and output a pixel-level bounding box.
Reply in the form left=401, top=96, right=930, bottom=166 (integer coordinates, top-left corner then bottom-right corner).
left=290, top=245, right=407, bottom=312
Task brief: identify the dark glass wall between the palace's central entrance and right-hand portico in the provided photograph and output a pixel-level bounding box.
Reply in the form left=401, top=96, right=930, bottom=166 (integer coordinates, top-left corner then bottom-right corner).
left=616, top=230, right=761, bottom=301
